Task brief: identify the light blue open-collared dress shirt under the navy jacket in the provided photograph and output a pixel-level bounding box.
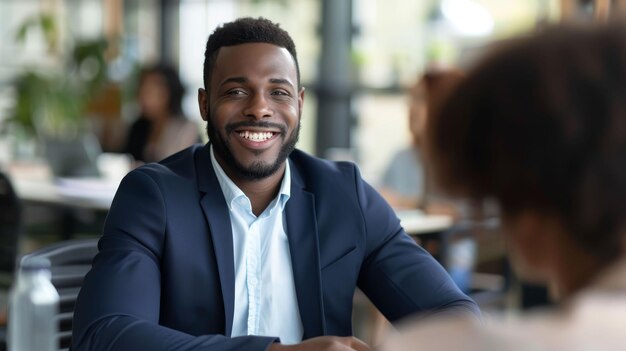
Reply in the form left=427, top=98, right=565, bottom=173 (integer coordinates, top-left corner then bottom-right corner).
left=211, top=147, right=303, bottom=344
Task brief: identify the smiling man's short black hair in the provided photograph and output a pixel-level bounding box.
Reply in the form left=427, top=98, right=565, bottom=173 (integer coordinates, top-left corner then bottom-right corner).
left=203, top=17, right=300, bottom=90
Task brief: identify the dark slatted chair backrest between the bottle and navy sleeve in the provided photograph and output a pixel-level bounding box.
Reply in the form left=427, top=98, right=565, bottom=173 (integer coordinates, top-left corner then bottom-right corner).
left=22, top=238, right=98, bottom=350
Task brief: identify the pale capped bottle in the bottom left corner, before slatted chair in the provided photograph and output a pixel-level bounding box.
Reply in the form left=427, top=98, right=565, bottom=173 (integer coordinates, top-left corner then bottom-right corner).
left=8, top=257, right=59, bottom=351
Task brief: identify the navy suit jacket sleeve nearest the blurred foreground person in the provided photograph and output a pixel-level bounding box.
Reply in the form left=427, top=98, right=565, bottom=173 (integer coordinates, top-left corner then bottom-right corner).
left=355, top=166, right=480, bottom=321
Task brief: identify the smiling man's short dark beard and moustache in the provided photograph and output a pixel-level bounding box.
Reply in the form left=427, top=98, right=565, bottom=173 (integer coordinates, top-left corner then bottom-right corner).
left=206, top=117, right=300, bottom=180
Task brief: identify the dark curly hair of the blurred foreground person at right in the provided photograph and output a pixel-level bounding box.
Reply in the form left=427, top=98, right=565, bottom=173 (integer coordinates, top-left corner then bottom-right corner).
left=427, top=24, right=626, bottom=262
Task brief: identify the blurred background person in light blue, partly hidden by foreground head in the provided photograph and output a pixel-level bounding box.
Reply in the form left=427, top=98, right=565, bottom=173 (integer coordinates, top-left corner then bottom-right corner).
left=378, top=68, right=463, bottom=216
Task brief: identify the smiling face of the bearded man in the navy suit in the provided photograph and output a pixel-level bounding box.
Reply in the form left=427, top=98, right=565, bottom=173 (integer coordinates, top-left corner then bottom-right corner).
left=198, top=43, right=304, bottom=180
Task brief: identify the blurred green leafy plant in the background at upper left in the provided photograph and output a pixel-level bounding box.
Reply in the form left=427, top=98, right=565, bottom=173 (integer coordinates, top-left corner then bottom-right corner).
left=8, top=13, right=107, bottom=176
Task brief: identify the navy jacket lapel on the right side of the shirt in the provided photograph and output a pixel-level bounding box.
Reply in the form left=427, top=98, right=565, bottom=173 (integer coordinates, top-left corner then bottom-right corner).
left=285, top=161, right=326, bottom=339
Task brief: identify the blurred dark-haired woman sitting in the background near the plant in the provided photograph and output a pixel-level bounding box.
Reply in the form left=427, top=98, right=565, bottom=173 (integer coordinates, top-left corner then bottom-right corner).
left=123, top=64, right=201, bottom=163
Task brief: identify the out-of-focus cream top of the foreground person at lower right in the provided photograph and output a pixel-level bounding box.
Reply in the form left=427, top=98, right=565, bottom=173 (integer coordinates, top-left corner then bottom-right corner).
left=381, top=257, right=626, bottom=351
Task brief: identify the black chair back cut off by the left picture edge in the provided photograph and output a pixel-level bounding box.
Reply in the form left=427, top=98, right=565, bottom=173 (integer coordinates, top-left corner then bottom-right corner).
left=0, top=172, right=22, bottom=351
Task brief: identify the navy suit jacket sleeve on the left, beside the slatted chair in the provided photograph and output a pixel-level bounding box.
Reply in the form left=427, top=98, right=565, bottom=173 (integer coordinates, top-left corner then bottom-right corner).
left=73, top=169, right=276, bottom=351
